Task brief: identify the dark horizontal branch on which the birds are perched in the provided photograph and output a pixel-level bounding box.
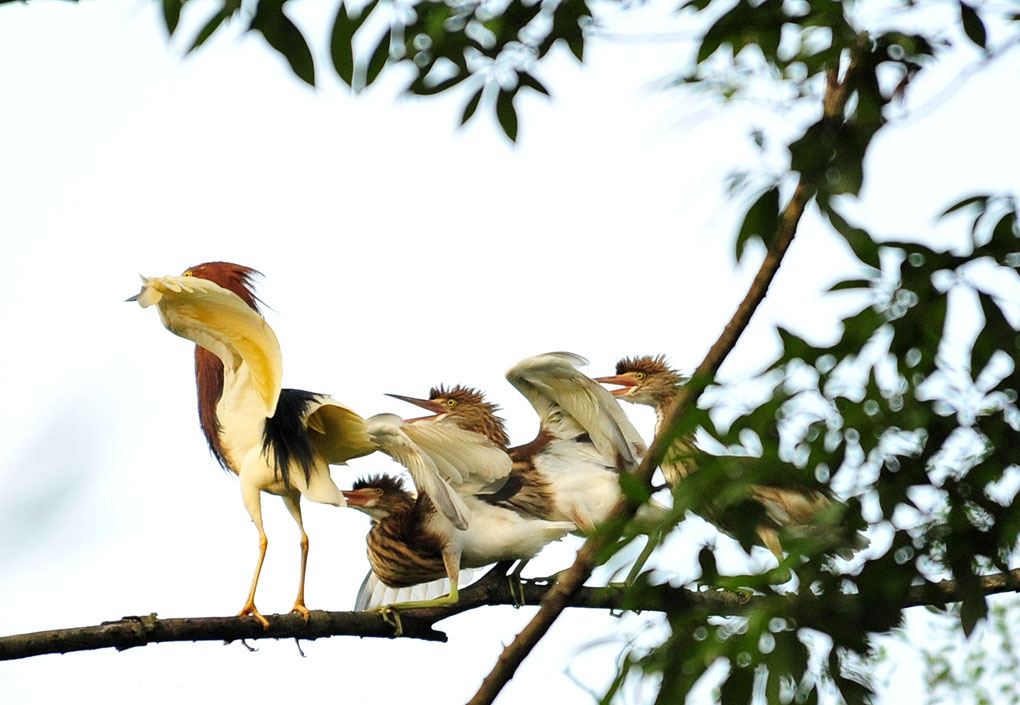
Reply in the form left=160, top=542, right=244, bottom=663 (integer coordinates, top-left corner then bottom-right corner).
left=7, top=570, right=1020, bottom=660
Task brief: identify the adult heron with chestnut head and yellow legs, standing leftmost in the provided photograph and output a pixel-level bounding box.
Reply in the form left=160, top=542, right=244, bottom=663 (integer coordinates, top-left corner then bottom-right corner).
left=129, top=261, right=376, bottom=627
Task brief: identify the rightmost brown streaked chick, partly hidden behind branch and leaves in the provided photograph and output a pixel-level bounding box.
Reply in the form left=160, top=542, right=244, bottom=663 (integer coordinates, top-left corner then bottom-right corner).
left=596, top=355, right=867, bottom=562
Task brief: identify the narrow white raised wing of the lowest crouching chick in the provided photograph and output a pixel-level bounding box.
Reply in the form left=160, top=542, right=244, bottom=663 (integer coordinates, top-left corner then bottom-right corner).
left=365, top=413, right=470, bottom=531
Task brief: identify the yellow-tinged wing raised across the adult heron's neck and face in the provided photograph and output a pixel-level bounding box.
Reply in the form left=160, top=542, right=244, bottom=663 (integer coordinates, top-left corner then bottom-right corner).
left=135, top=276, right=284, bottom=417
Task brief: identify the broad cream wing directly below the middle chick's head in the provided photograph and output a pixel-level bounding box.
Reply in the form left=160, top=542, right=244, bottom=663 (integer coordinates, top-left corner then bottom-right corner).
left=404, top=418, right=513, bottom=496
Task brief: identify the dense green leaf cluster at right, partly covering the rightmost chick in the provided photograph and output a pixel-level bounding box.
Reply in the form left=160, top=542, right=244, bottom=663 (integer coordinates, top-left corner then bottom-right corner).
left=607, top=191, right=1020, bottom=703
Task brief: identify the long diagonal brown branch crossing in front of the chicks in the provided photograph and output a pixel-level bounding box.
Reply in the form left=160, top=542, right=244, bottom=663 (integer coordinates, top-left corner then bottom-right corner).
left=467, top=38, right=866, bottom=705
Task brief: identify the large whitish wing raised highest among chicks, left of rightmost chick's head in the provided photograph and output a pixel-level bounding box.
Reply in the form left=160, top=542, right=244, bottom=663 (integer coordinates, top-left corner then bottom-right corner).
left=507, top=352, right=645, bottom=467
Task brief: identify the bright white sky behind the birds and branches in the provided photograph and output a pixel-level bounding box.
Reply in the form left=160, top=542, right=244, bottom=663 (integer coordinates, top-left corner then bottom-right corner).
left=0, top=0, right=1020, bottom=705
